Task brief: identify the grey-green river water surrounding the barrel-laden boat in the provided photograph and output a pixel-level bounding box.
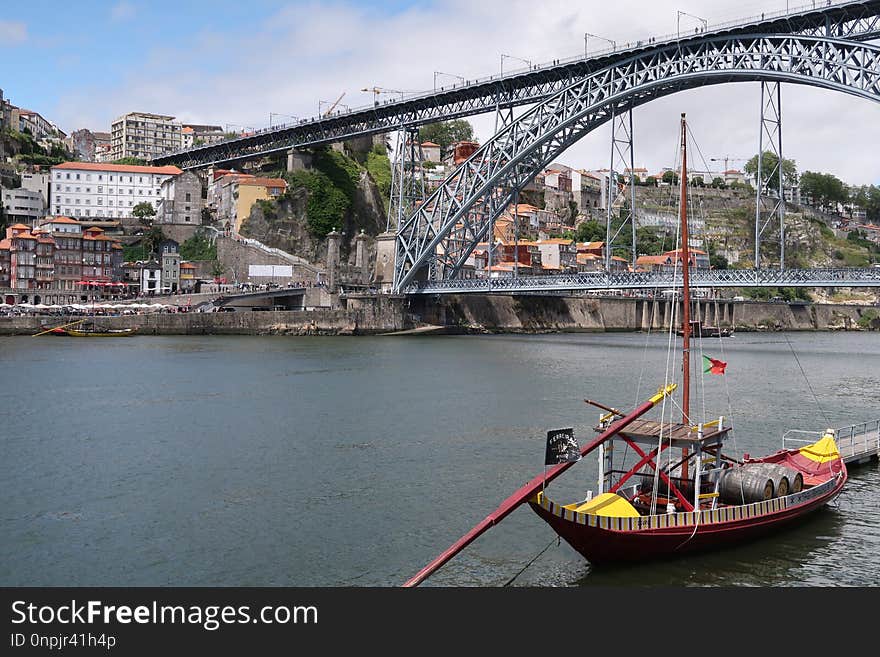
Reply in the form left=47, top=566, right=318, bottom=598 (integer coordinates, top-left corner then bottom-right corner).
left=0, top=333, right=880, bottom=587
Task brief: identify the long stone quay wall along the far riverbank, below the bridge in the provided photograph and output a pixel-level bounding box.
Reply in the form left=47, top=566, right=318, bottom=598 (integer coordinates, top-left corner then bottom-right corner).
left=0, top=295, right=880, bottom=335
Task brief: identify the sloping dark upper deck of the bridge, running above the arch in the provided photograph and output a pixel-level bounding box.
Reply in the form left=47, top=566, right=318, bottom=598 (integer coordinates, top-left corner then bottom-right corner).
left=152, top=0, right=880, bottom=169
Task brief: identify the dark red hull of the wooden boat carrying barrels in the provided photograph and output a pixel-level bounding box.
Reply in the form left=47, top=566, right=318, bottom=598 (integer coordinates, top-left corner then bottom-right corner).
left=529, top=470, right=847, bottom=564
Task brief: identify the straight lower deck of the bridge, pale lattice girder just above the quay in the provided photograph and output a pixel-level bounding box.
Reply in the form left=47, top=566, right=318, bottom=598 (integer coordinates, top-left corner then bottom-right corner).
left=405, top=267, right=880, bottom=294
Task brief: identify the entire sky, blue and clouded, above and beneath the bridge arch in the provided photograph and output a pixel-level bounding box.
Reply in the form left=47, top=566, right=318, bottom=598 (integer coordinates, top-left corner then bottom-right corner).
left=0, top=0, right=880, bottom=185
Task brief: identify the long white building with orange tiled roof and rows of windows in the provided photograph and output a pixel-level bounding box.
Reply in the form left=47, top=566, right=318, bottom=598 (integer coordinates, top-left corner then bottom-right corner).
left=50, top=162, right=182, bottom=219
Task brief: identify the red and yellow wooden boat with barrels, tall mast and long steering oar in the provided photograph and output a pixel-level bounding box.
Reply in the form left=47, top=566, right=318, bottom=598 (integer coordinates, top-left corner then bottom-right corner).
left=404, top=114, right=848, bottom=586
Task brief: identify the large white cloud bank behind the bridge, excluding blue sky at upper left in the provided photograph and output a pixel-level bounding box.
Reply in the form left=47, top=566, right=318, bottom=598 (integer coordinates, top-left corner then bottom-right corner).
left=56, top=0, right=880, bottom=184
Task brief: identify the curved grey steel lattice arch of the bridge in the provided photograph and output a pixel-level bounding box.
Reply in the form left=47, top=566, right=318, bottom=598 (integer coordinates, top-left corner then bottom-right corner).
left=395, top=35, right=880, bottom=290
